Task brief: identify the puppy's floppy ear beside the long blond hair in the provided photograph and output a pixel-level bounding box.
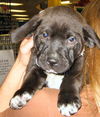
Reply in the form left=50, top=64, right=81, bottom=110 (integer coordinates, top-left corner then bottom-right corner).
left=83, top=25, right=100, bottom=48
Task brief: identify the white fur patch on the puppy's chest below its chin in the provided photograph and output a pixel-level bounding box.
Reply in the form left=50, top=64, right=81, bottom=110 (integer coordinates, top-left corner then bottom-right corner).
left=46, top=73, right=64, bottom=89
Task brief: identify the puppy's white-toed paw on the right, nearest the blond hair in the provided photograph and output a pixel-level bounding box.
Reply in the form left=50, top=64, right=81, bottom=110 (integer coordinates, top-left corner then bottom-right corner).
left=58, top=95, right=81, bottom=116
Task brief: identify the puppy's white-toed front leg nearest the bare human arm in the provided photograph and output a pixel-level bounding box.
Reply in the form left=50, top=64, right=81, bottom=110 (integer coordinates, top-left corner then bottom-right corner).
left=9, top=64, right=46, bottom=109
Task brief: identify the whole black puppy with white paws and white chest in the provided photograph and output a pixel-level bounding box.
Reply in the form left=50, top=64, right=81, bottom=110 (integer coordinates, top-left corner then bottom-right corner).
left=10, top=6, right=100, bottom=116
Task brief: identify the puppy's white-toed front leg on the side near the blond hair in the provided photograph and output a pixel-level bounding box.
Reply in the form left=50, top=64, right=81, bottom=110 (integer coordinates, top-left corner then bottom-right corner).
left=58, top=57, right=84, bottom=116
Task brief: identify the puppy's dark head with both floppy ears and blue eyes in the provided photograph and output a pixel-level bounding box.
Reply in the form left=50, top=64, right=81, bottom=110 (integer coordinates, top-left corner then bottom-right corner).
left=12, top=6, right=100, bottom=73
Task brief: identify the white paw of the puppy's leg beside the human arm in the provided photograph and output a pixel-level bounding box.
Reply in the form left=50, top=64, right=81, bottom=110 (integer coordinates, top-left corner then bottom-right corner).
left=9, top=92, right=32, bottom=109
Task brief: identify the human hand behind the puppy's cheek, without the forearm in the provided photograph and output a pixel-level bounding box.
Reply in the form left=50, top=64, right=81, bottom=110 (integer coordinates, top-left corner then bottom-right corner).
left=17, top=37, right=34, bottom=67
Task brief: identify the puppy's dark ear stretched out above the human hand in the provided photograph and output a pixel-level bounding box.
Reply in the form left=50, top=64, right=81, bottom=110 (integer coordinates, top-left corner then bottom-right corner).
left=11, top=15, right=41, bottom=43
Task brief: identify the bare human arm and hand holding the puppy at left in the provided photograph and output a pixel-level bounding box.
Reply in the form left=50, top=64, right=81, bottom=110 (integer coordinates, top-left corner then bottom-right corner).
left=0, top=38, right=33, bottom=112
